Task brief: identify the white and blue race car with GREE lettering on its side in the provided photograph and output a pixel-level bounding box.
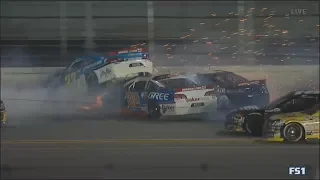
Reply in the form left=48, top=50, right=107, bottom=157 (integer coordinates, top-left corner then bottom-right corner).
left=121, top=72, right=217, bottom=119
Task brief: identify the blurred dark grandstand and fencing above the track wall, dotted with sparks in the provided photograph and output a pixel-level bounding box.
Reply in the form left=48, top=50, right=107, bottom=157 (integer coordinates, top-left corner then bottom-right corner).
left=1, top=1, right=319, bottom=67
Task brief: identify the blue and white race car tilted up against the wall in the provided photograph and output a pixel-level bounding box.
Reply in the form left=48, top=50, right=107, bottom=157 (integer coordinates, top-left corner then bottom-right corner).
left=43, top=48, right=153, bottom=95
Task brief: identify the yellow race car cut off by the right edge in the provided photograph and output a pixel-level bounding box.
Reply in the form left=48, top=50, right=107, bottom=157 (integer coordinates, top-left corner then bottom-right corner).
left=263, top=104, right=320, bottom=142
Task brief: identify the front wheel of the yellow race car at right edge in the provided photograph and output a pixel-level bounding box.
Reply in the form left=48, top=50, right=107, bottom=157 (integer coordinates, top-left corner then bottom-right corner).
left=282, top=123, right=305, bottom=142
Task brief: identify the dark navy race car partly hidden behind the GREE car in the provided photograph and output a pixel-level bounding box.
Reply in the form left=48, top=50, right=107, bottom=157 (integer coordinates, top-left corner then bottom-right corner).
left=188, top=70, right=269, bottom=110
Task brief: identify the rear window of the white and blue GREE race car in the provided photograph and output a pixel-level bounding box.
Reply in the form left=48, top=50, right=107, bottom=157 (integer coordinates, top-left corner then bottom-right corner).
left=159, top=78, right=197, bottom=89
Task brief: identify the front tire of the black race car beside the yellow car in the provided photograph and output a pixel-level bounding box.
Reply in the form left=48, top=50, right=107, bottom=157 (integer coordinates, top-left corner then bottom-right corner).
left=243, top=114, right=263, bottom=136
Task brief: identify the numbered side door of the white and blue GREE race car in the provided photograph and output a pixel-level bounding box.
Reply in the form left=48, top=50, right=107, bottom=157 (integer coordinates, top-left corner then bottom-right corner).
left=126, top=80, right=147, bottom=110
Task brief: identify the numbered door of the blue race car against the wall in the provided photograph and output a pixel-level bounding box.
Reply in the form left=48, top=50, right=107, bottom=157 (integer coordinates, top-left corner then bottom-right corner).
left=63, top=60, right=83, bottom=86
